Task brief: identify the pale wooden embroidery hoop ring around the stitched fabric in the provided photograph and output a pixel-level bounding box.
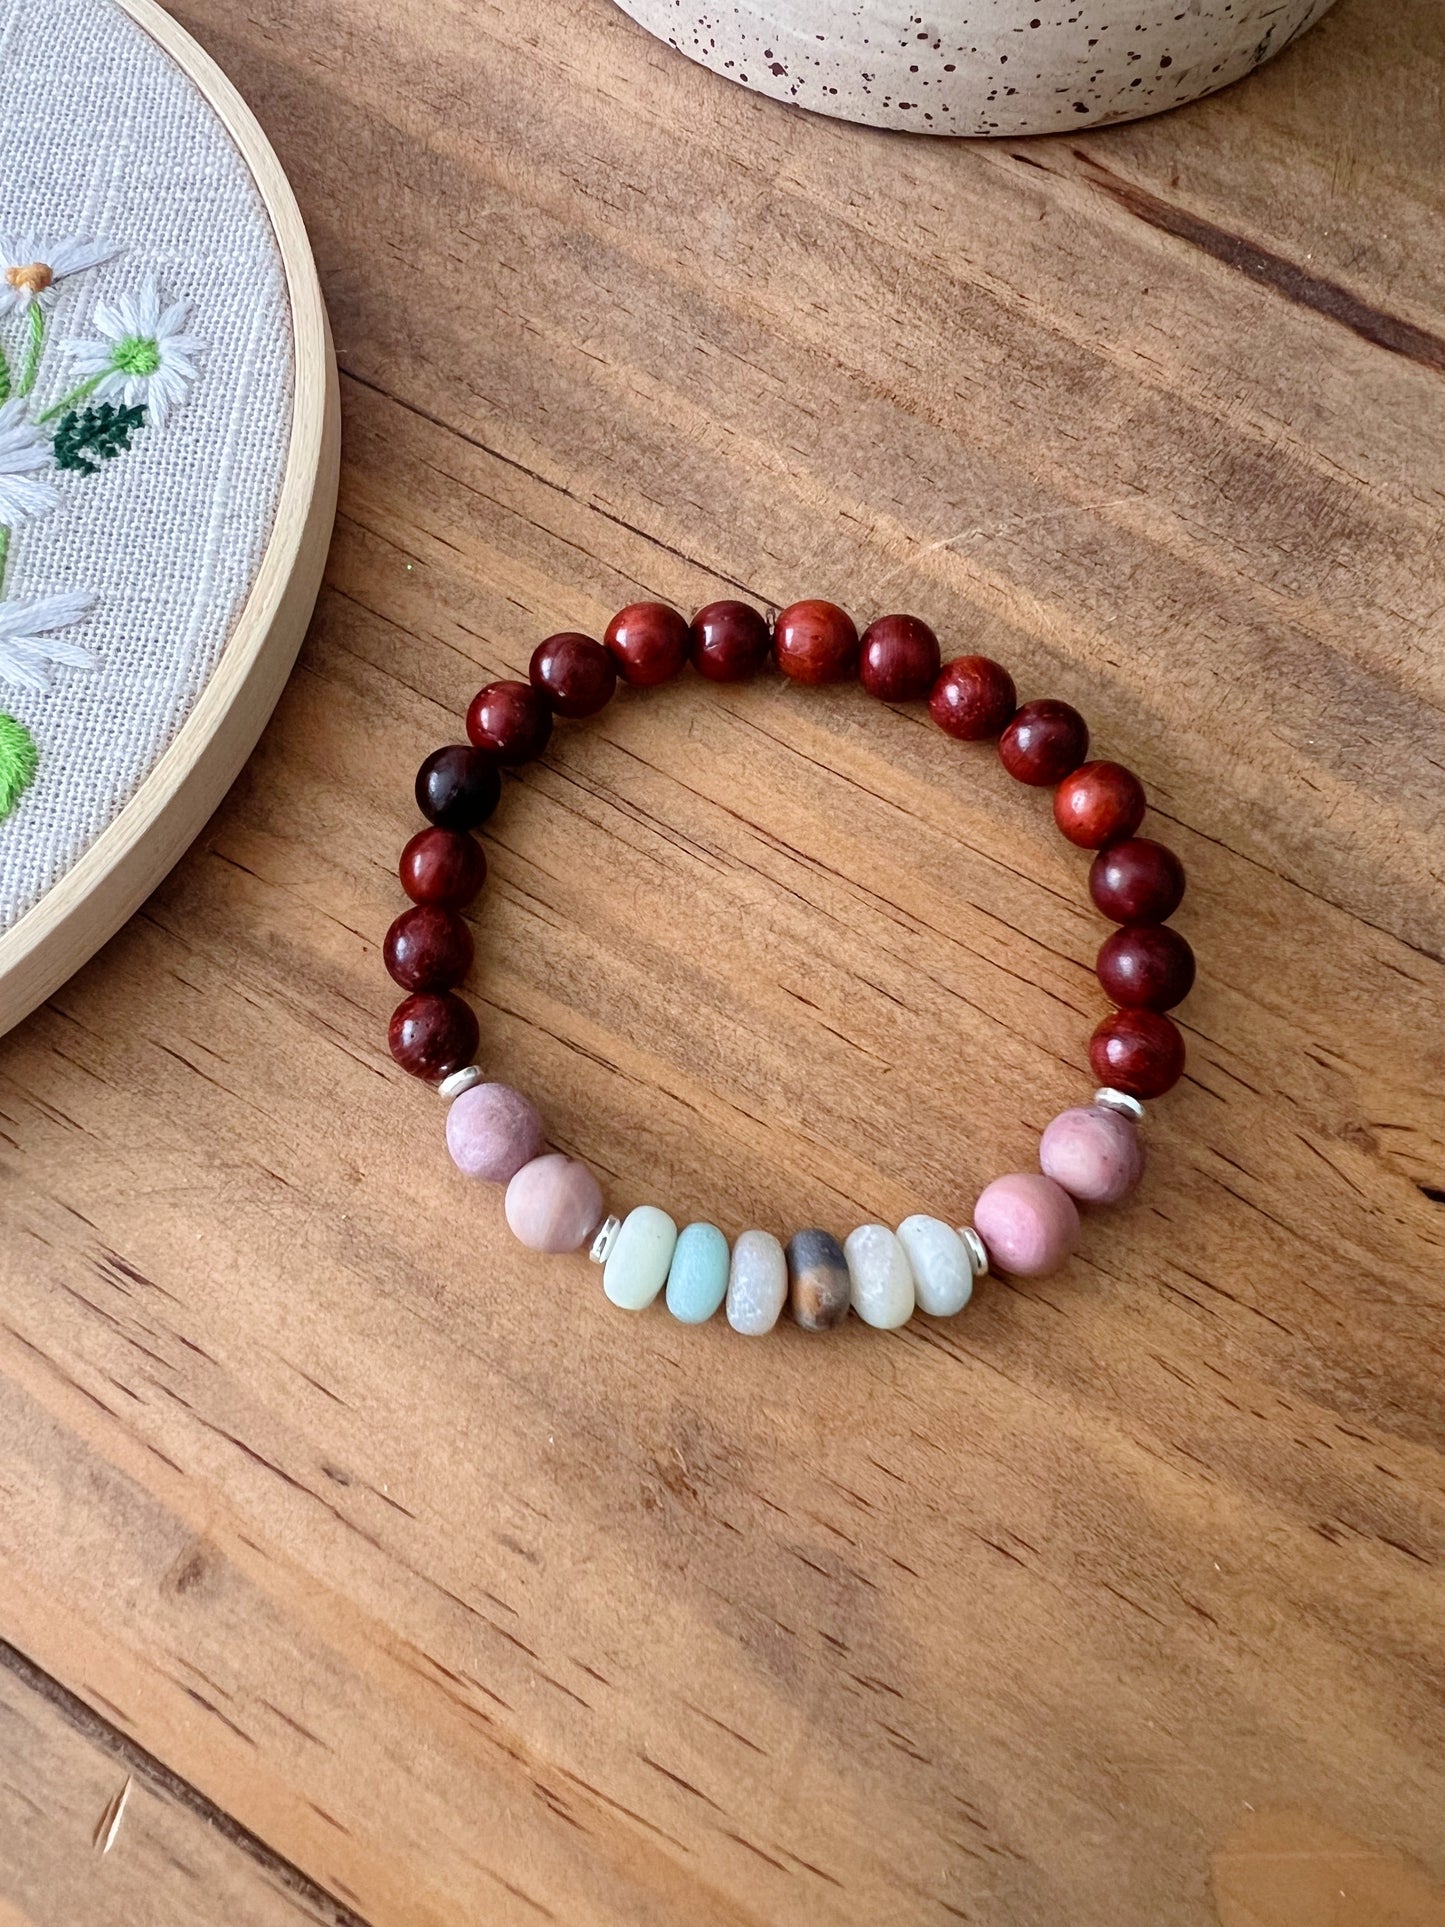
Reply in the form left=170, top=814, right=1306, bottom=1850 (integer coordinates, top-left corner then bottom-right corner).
left=0, top=0, right=341, bottom=1035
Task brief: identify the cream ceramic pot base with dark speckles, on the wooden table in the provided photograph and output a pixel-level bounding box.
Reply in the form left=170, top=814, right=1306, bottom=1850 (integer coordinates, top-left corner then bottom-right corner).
left=618, top=0, right=1331, bottom=135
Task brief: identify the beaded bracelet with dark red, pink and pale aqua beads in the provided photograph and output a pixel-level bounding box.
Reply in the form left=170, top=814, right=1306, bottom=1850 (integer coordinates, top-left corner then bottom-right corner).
left=385, top=601, right=1195, bottom=1335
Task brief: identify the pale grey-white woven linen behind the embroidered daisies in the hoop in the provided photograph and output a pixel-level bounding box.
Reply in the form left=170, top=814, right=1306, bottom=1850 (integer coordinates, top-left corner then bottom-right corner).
left=0, top=0, right=293, bottom=931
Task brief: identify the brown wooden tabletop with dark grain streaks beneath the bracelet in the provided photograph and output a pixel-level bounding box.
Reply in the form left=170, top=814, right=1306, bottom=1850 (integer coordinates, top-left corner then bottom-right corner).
left=0, top=0, right=1445, bottom=1927
